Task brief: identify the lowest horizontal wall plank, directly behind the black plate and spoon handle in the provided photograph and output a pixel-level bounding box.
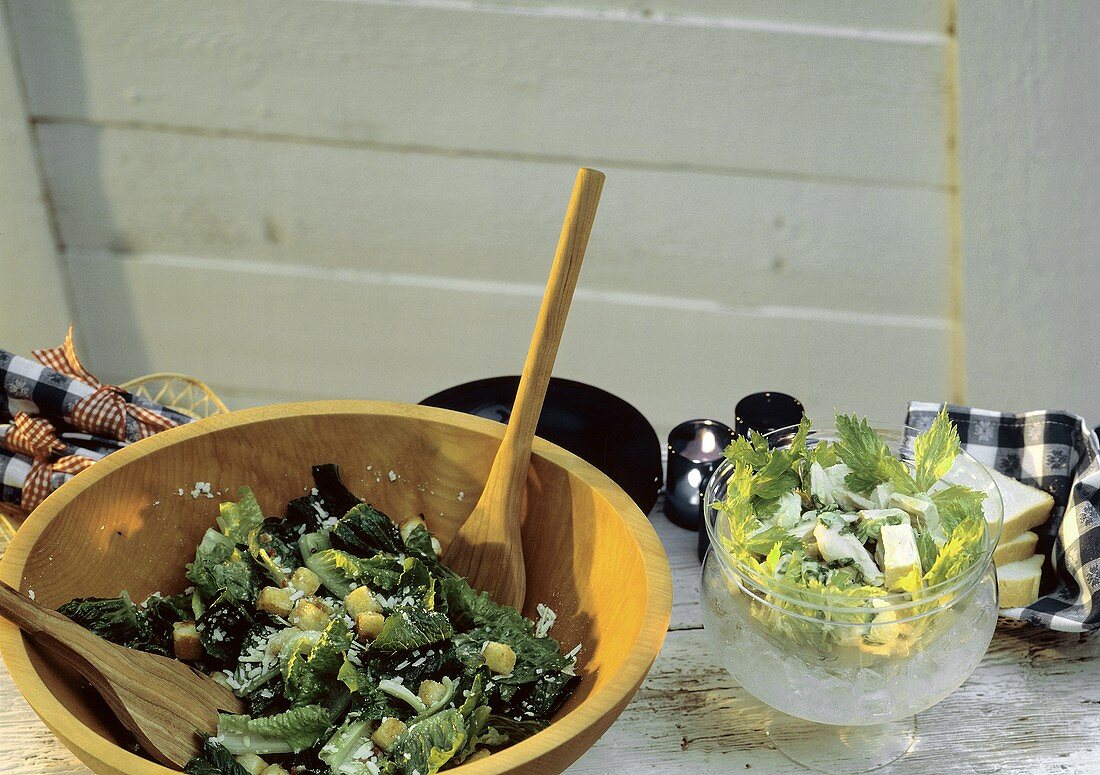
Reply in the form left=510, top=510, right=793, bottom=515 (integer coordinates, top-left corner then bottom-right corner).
left=64, top=248, right=947, bottom=435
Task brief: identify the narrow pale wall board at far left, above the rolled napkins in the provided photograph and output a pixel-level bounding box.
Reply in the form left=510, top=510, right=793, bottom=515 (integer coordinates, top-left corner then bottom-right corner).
left=0, top=2, right=72, bottom=353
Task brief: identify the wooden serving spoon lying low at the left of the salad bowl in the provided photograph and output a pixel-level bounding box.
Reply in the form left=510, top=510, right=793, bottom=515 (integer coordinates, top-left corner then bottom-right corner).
left=0, top=582, right=245, bottom=770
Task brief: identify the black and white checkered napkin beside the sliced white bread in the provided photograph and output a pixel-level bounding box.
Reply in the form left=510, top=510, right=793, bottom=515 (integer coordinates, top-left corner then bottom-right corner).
left=906, top=401, right=1100, bottom=632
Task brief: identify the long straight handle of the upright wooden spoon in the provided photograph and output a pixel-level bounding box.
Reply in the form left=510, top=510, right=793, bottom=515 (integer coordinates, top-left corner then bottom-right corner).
left=488, top=167, right=604, bottom=507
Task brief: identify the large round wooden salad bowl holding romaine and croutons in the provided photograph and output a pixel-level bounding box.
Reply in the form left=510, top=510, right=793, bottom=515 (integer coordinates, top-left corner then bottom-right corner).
left=0, top=401, right=672, bottom=775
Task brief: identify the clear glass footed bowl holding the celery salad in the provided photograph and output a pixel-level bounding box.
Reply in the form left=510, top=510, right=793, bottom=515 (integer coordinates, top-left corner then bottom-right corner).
left=702, top=428, right=1002, bottom=771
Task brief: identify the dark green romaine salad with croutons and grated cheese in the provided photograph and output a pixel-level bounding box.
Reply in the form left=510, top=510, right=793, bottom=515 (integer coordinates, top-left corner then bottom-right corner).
left=59, top=465, right=580, bottom=775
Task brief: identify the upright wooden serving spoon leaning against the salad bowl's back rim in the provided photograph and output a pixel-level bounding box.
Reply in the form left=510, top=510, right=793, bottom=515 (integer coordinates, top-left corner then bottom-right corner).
left=443, top=167, right=604, bottom=610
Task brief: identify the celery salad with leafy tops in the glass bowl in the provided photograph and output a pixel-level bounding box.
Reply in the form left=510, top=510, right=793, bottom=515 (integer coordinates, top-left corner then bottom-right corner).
left=714, top=412, right=987, bottom=660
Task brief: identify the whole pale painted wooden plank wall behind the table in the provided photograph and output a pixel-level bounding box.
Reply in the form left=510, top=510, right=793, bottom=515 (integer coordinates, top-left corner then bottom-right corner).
left=0, top=0, right=1100, bottom=434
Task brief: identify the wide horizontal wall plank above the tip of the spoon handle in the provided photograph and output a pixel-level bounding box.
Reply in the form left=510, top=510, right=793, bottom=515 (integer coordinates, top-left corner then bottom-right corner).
left=12, top=0, right=946, bottom=187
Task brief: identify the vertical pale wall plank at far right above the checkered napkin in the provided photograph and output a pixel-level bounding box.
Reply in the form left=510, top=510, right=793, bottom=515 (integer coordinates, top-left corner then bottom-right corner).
left=958, top=2, right=1100, bottom=425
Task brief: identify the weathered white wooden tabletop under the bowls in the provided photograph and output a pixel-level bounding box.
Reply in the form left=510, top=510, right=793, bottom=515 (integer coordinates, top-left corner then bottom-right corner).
left=0, top=505, right=1100, bottom=775
